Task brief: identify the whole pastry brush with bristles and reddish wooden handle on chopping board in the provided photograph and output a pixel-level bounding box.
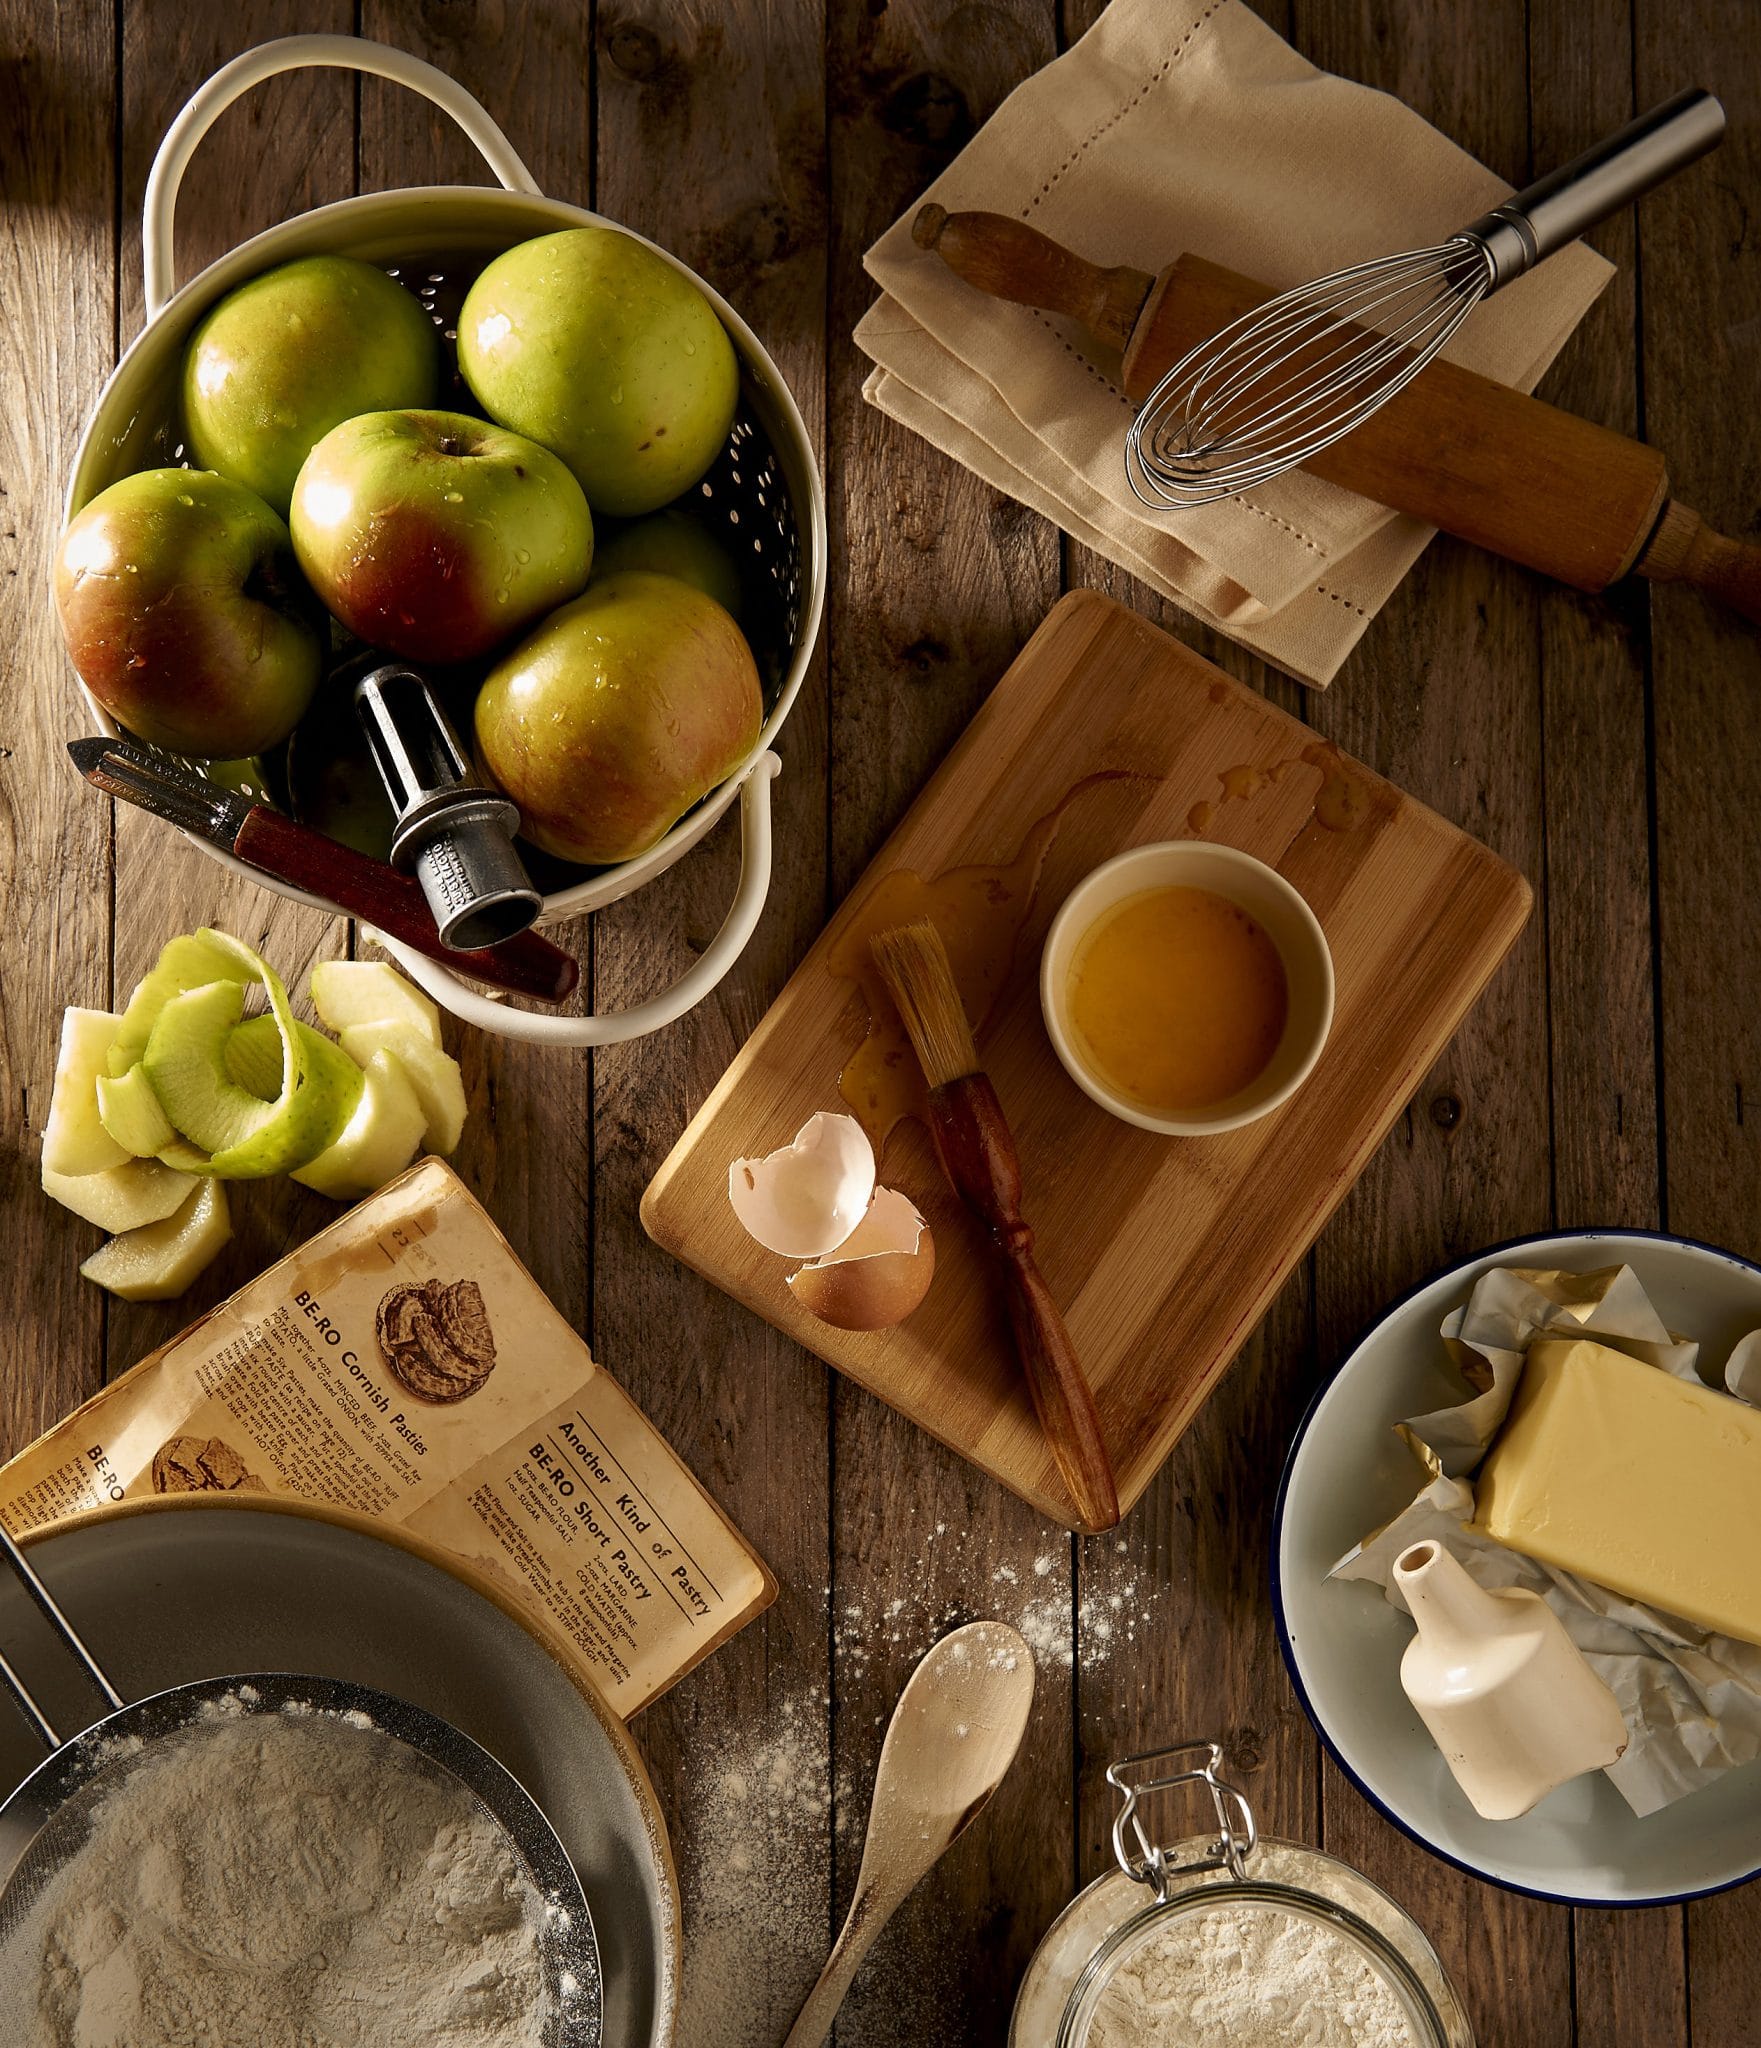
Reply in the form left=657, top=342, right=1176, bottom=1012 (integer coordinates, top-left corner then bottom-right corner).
left=868, top=920, right=1118, bottom=1532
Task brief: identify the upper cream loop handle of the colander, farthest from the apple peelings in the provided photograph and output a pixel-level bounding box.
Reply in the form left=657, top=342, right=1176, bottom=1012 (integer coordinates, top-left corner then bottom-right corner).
left=141, top=35, right=539, bottom=319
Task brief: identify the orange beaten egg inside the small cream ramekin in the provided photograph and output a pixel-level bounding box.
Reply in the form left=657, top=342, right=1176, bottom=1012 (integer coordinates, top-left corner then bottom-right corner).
left=1069, top=887, right=1290, bottom=1116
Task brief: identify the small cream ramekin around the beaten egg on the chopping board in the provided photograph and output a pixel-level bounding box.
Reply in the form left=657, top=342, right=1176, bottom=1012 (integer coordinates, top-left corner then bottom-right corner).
left=1040, top=840, right=1333, bottom=1139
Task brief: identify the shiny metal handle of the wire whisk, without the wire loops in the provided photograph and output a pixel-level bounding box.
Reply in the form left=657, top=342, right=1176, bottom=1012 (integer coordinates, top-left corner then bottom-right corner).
left=1464, top=88, right=1724, bottom=291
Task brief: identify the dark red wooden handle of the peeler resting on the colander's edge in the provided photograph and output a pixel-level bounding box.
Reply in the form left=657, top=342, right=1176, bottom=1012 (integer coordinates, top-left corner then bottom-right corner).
left=233, top=803, right=582, bottom=1004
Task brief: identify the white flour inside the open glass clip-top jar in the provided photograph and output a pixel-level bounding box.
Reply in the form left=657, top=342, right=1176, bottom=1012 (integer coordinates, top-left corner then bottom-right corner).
left=1085, top=1907, right=1415, bottom=2048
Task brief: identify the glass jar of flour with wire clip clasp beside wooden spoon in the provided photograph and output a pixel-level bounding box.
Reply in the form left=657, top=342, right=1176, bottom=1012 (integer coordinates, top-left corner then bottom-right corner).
left=1010, top=1743, right=1474, bottom=2048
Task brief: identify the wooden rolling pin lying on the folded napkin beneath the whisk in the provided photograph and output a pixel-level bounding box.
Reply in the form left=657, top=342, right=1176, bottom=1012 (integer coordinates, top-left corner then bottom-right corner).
left=911, top=205, right=1761, bottom=623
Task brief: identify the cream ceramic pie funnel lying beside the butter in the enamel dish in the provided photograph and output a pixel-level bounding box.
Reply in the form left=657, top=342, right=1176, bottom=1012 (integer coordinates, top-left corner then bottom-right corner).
left=1394, top=1540, right=1626, bottom=1821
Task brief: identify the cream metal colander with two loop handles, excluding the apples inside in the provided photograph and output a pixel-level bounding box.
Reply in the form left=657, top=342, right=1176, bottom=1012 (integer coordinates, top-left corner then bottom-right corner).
left=66, top=35, right=827, bottom=1047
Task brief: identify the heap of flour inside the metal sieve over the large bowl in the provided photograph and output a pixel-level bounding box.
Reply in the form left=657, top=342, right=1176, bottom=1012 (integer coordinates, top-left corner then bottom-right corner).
left=0, top=1702, right=549, bottom=2048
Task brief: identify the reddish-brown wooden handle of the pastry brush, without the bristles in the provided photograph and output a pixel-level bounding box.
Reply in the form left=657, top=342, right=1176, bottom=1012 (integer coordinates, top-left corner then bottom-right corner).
left=930, top=1073, right=1118, bottom=1534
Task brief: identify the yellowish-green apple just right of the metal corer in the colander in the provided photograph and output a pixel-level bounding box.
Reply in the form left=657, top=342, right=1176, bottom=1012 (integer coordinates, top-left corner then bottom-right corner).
left=475, top=569, right=764, bottom=866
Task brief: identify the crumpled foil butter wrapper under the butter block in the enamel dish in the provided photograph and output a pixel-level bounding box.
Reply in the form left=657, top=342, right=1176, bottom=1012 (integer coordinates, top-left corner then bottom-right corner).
left=1331, top=1266, right=1761, bottom=1815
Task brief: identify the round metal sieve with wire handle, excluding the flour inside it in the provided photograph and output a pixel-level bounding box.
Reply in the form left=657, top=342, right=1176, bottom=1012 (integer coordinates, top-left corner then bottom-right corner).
left=0, top=1528, right=602, bottom=2048
